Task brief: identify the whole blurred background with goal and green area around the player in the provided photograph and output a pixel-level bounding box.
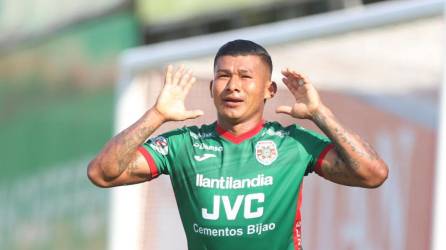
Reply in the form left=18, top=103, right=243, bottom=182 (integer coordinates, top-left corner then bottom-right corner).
left=0, top=0, right=445, bottom=250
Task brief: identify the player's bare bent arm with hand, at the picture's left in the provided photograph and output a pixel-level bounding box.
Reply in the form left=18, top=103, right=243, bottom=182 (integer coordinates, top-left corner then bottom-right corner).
left=88, top=66, right=203, bottom=187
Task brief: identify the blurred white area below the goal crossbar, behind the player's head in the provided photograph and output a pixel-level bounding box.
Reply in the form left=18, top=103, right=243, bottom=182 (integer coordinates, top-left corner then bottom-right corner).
left=184, top=16, right=445, bottom=94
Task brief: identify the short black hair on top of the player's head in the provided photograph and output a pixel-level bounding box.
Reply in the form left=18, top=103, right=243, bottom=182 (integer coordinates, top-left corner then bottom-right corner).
left=214, top=39, right=273, bottom=74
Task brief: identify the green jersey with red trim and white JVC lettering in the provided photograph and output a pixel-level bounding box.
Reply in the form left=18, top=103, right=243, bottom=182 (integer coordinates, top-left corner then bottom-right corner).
left=139, top=122, right=331, bottom=250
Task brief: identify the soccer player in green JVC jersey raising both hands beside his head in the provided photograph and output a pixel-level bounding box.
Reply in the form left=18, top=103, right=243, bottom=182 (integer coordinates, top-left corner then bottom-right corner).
left=88, top=40, right=388, bottom=250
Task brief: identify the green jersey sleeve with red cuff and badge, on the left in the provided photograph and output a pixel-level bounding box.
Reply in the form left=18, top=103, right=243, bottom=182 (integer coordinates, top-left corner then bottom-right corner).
left=138, top=129, right=184, bottom=178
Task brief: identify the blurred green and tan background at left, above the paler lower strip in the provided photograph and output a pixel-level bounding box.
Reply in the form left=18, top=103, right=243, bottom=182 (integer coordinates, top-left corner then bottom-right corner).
left=0, top=11, right=138, bottom=180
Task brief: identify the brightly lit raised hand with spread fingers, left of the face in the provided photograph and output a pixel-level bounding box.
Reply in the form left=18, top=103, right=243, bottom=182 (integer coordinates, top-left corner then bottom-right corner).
left=155, top=65, right=203, bottom=121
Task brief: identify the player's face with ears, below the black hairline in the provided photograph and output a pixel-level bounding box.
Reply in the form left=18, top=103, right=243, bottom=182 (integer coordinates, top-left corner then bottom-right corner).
left=211, top=55, right=275, bottom=123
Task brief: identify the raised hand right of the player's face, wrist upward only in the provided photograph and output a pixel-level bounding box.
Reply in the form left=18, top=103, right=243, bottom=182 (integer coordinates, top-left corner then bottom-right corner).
left=276, top=68, right=321, bottom=119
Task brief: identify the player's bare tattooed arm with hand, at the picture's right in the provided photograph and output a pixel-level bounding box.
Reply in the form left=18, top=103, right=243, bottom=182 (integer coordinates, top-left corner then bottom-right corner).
left=277, top=69, right=388, bottom=188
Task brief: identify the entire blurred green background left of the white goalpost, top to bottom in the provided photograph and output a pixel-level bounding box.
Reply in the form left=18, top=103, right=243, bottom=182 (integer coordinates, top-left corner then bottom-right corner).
left=0, top=9, right=139, bottom=250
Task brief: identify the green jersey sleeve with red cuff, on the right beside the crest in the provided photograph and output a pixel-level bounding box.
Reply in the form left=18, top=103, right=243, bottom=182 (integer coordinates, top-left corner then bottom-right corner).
left=291, top=125, right=333, bottom=175
